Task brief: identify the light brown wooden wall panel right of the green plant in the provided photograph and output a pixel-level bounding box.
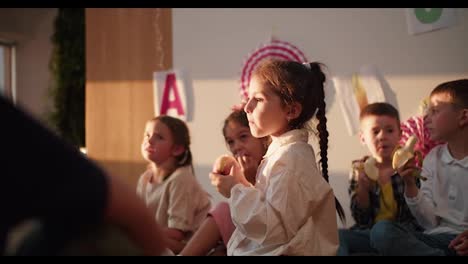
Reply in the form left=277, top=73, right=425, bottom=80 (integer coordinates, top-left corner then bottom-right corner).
left=86, top=8, right=172, bottom=188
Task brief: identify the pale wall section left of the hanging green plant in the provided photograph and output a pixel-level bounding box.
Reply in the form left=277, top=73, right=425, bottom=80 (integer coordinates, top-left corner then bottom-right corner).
left=0, top=8, right=57, bottom=120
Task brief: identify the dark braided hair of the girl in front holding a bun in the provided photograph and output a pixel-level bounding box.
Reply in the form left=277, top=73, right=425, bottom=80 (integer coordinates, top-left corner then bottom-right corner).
left=254, top=59, right=345, bottom=221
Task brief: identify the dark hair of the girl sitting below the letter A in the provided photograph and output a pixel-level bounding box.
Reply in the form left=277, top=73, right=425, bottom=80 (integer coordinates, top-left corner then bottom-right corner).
left=150, top=115, right=193, bottom=169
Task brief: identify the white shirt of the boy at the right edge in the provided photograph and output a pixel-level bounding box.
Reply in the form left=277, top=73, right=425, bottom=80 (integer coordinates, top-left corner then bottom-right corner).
left=405, top=144, right=468, bottom=234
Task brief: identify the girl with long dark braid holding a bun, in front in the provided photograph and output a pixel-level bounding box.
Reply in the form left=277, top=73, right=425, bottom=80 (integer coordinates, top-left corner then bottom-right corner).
left=210, top=60, right=344, bottom=255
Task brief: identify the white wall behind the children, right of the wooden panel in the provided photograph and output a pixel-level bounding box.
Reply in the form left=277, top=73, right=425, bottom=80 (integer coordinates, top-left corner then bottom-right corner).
left=173, top=8, right=468, bottom=226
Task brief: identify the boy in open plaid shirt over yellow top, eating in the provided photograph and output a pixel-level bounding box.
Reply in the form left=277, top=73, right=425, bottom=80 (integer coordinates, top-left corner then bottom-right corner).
left=338, top=103, right=421, bottom=255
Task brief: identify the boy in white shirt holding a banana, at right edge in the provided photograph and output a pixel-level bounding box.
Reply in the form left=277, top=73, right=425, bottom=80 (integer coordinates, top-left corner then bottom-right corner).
left=374, top=79, right=468, bottom=255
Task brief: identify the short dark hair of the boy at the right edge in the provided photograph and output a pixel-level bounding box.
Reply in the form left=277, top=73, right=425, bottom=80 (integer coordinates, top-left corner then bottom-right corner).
left=431, top=79, right=468, bottom=108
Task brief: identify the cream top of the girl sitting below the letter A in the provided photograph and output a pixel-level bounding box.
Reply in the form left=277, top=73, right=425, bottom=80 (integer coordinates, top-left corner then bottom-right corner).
left=137, top=166, right=211, bottom=232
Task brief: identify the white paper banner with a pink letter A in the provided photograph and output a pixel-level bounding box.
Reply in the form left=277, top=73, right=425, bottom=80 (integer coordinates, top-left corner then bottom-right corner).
left=153, top=70, right=193, bottom=121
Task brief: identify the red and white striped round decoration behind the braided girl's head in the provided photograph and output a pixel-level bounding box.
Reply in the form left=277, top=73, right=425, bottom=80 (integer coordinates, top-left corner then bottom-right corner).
left=240, top=39, right=307, bottom=101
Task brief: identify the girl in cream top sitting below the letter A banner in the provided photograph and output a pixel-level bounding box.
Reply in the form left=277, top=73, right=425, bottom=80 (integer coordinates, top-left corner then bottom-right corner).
left=137, top=115, right=211, bottom=254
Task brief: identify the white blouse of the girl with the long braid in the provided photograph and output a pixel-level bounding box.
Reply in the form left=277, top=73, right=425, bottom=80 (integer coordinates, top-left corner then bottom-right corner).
left=227, top=130, right=338, bottom=255
